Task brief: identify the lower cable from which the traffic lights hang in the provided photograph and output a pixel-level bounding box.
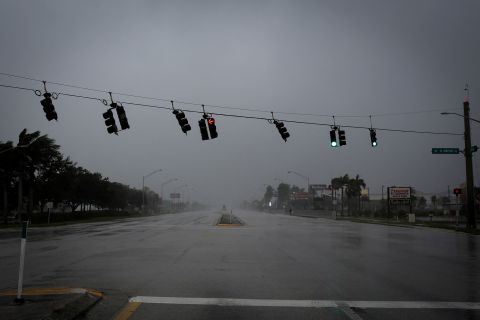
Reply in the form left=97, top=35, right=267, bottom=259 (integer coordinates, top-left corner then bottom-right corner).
left=0, top=84, right=463, bottom=136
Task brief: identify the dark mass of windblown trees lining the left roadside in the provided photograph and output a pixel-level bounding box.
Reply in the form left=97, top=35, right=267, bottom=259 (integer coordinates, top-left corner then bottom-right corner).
left=0, top=129, right=159, bottom=223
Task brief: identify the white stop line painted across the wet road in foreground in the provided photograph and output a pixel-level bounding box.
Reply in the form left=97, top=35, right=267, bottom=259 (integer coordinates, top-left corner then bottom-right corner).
left=129, top=296, right=480, bottom=310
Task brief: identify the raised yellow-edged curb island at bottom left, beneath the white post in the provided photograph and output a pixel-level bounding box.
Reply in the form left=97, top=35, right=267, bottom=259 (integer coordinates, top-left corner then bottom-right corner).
left=0, top=288, right=103, bottom=320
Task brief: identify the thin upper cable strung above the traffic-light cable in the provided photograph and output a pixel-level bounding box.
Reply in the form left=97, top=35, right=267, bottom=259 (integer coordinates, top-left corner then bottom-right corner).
left=0, top=72, right=461, bottom=118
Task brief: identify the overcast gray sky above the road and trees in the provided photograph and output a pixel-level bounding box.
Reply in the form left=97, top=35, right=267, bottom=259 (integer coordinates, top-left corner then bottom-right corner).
left=0, top=0, right=480, bottom=203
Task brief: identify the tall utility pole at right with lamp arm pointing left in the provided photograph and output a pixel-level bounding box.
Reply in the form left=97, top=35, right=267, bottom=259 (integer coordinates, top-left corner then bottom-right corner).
left=441, top=94, right=480, bottom=229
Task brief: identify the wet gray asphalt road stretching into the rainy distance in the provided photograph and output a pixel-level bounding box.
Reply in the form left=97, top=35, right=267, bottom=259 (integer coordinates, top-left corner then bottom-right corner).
left=0, top=210, right=480, bottom=320
